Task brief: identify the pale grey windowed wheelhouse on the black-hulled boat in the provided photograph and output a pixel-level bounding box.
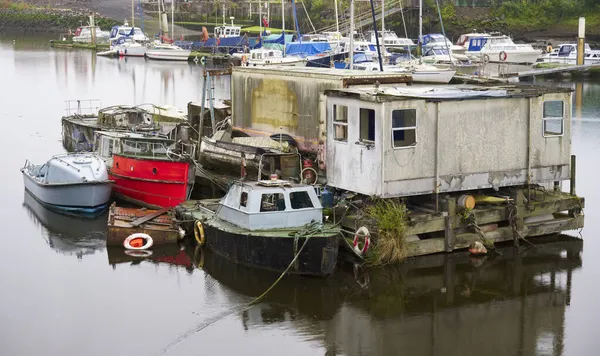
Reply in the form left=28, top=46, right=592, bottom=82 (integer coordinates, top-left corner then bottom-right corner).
left=217, top=180, right=323, bottom=231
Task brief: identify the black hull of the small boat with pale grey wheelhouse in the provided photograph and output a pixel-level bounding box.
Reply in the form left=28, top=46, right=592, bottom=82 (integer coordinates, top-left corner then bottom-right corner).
left=204, top=220, right=339, bottom=276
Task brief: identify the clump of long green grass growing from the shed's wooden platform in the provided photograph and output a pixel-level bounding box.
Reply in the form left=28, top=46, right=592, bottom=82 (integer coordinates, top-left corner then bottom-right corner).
left=365, top=199, right=409, bottom=265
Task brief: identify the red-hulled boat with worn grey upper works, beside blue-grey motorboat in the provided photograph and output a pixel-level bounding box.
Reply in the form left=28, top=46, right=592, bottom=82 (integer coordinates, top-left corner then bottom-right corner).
left=109, top=137, right=195, bottom=209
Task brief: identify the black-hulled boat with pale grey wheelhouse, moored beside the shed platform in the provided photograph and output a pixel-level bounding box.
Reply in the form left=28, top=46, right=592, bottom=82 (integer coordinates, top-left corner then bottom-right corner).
left=176, top=179, right=340, bottom=276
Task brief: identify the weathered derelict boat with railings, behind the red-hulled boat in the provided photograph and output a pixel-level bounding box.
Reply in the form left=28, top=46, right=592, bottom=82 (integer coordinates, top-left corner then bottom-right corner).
left=62, top=100, right=187, bottom=152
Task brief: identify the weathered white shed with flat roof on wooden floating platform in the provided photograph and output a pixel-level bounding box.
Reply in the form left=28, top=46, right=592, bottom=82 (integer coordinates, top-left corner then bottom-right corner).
left=322, top=85, right=571, bottom=197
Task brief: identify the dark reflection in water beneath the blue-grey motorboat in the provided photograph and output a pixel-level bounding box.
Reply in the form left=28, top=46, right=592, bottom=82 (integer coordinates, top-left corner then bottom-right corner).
left=23, top=191, right=108, bottom=259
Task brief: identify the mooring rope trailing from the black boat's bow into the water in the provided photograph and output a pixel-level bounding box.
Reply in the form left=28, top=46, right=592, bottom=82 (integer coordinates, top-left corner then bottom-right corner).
left=160, top=222, right=324, bottom=355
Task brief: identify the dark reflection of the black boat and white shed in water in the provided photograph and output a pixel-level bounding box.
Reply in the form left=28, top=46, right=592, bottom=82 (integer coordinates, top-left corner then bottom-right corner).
left=195, top=236, right=583, bottom=355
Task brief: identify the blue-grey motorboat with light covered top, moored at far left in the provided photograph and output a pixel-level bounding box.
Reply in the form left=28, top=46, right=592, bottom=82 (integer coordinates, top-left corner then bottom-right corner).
left=21, top=153, right=113, bottom=216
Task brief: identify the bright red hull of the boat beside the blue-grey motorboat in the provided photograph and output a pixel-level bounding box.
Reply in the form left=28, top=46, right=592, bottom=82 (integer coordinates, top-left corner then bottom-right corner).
left=109, top=154, right=194, bottom=208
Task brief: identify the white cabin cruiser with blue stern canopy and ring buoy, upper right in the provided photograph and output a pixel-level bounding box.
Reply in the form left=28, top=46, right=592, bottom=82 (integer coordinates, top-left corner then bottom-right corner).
left=465, top=35, right=542, bottom=64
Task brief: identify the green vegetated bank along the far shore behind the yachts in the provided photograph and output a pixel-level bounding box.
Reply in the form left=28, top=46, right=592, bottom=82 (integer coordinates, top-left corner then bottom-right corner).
left=0, top=0, right=600, bottom=41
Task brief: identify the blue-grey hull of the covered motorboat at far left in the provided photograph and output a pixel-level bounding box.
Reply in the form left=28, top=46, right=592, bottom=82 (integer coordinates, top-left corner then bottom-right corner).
left=23, top=172, right=112, bottom=215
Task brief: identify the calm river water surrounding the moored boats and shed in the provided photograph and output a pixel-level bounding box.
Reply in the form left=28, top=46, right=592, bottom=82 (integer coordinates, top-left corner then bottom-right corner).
left=0, top=35, right=600, bottom=355
